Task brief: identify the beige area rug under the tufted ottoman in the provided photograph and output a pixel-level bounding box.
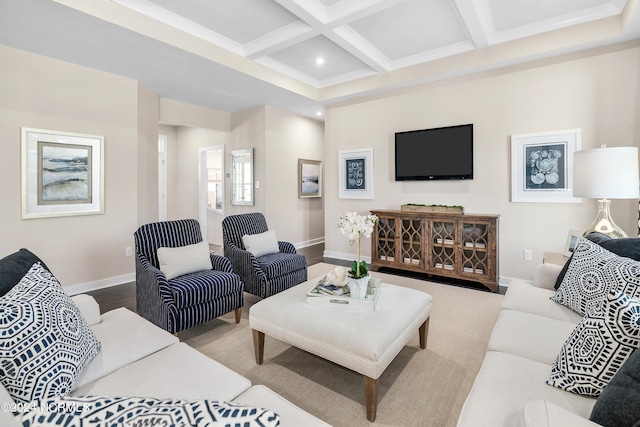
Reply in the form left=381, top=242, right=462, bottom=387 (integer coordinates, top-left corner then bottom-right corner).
left=179, top=263, right=503, bottom=427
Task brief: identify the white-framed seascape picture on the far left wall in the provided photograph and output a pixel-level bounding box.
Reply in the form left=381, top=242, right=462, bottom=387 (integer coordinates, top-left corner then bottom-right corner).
left=22, top=128, right=104, bottom=219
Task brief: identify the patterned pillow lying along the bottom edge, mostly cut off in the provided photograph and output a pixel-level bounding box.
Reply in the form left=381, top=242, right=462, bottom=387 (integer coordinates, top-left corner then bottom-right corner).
left=14, top=396, right=280, bottom=427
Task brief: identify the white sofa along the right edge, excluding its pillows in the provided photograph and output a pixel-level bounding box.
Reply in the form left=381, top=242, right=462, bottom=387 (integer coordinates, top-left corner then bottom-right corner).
left=458, top=264, right=597, bottom=427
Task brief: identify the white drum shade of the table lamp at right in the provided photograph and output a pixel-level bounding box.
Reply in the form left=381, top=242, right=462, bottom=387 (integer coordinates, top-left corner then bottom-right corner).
left=573, top=147, right=640, bottom=199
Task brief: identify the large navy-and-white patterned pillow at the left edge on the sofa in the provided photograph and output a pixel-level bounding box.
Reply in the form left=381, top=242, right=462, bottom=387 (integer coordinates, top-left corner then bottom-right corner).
left=0, top=263, right=100, bottom=402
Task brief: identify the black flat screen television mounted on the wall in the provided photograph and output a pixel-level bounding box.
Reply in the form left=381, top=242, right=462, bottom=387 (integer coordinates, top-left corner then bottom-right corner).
left=395, top=124, right=473, bottom=181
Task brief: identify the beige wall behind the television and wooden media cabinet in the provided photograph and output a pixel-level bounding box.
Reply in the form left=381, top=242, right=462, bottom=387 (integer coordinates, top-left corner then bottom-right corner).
left=324, top=43, right=640, bottom=279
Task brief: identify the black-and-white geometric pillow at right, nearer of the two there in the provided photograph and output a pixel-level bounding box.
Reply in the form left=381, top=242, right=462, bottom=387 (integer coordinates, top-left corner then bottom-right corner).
left=547, top=291, right=640, bottom=396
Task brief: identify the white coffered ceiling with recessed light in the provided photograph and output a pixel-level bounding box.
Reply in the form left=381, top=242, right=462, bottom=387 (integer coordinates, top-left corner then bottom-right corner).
left=0, top=0, right=640, bottom=117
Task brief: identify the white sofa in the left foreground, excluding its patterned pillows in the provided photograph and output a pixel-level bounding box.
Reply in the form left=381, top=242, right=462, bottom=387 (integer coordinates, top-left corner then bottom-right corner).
left=0, top=295, right=328, bottom=426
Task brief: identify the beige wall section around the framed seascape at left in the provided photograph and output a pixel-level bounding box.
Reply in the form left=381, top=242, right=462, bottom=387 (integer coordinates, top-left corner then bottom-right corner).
left=0, top=46, right=139, bottom=286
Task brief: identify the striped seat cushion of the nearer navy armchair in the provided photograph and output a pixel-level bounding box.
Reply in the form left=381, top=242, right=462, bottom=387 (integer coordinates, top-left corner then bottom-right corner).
left=169, top=270, right=243, bottom=308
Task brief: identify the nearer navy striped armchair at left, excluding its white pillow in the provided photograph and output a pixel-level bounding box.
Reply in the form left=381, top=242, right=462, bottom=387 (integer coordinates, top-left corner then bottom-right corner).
left=134, top=219, right=244, bottom=334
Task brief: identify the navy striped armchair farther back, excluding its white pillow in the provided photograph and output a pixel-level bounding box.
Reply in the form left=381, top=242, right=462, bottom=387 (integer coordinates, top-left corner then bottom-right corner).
left=222, top=212, right=307, bottom=298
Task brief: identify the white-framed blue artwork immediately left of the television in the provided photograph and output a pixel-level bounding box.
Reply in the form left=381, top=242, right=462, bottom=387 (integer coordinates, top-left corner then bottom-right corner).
left=338, top=148, right=373, bottom=199
